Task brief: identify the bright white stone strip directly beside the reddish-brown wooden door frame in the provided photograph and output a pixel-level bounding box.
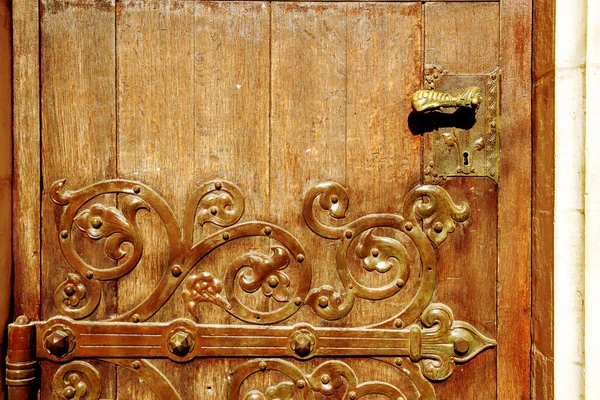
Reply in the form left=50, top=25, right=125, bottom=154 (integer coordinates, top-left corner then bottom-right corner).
left=554, top=0, right=584, bottom=400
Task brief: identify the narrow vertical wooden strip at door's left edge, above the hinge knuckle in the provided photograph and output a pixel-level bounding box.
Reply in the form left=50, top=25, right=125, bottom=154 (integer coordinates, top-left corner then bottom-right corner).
left=12, top=1, right=41, bottom=320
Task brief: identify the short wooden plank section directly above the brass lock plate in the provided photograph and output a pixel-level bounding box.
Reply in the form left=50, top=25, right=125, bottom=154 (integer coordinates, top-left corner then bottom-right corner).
left=425, top=2, right=500, bottom=74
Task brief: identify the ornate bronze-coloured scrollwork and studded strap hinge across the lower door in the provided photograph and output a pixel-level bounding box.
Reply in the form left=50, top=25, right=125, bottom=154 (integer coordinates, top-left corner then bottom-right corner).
left=43, top=180, right=495, bottom=400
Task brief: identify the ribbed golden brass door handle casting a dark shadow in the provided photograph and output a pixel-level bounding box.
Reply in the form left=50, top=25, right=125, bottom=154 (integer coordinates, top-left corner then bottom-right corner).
left=412, top=86, right=481, bottom=112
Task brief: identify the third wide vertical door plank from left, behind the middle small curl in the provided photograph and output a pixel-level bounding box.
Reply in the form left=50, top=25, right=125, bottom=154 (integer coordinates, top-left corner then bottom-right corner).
left=189, top=2, right=270, bottom=324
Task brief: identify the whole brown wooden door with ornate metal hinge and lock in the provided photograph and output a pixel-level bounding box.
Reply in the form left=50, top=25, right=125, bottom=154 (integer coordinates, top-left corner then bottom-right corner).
left=7, top=0, right=531, bottom=400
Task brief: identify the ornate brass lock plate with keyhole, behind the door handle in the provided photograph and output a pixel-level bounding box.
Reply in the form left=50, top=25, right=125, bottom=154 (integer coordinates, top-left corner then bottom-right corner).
left=418, top=65, right=501, bottom=184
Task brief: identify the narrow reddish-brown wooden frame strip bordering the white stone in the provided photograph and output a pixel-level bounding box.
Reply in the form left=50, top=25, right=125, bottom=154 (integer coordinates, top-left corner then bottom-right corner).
left=531, top=0, right=556, bottom=400
